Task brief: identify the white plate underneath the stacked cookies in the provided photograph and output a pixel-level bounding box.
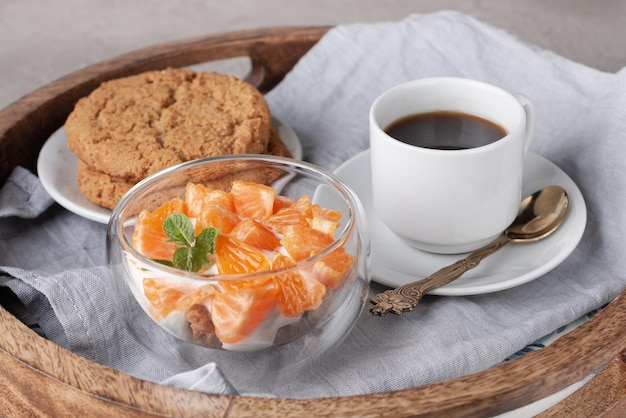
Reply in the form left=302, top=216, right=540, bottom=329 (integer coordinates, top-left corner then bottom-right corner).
left=37, top=118, right=302, bottom=224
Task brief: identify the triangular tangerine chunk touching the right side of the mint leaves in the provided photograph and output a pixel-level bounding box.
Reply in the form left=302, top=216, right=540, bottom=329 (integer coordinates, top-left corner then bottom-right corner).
left=215, top=234, right=270, bottom=274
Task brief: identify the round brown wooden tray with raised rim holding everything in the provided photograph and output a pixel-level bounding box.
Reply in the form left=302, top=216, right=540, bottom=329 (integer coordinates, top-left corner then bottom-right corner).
left=0, top=27, right=626, bottom=417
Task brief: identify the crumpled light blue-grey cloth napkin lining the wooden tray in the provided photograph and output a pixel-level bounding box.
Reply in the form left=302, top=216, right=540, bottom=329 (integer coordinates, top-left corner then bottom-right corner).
left=0, top=12, right=626, bottom=398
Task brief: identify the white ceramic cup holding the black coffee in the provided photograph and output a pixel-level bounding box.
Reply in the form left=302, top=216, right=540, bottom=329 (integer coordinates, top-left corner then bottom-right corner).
left=369, top=77, right=534, bottom=254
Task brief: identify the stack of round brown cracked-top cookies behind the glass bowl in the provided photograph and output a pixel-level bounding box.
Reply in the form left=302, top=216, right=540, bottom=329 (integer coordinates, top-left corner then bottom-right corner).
left=65, top=69, right=289, bottom=208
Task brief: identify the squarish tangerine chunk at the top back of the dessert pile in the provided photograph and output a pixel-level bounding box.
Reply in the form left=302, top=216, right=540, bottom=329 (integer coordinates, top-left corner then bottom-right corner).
left=230, top=181, right=276, bottom=220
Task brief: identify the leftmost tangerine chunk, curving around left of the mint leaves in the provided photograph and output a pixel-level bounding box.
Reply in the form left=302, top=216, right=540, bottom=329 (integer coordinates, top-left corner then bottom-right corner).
left=132, top=198, right=187, bottom=260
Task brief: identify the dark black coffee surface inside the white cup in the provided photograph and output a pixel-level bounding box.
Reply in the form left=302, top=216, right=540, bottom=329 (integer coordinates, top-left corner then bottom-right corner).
left=385, top=111, right=507, bottom=150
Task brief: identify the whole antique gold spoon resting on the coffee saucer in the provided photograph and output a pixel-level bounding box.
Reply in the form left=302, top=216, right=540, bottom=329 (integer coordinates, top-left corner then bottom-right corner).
left=370, top=186, right=569, bottom=315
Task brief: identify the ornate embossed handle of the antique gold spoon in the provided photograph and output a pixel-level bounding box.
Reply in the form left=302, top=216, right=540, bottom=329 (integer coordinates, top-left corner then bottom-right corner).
left=370, top=235, right=511, bottom=315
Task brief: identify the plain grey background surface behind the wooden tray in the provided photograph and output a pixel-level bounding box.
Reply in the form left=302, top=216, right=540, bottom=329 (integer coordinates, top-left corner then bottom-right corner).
left=0, top=0, right=626, bottom=108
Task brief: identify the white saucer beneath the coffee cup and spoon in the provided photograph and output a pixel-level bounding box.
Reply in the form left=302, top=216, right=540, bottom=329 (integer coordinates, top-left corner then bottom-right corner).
left=335, top=150, right=587, bottom=296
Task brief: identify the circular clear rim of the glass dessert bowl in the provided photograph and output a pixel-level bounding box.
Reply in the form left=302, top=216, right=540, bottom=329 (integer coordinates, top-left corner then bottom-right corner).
left=108, top=154, right=359, bottom=283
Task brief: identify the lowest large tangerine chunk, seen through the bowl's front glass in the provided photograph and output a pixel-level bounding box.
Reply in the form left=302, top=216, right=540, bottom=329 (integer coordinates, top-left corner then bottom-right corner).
left=211, top=283, right=276, bottom=344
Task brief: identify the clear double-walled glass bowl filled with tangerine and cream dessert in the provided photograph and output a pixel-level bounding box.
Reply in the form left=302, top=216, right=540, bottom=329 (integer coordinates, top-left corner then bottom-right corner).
left=107, top=155, right=370, bottom=390
